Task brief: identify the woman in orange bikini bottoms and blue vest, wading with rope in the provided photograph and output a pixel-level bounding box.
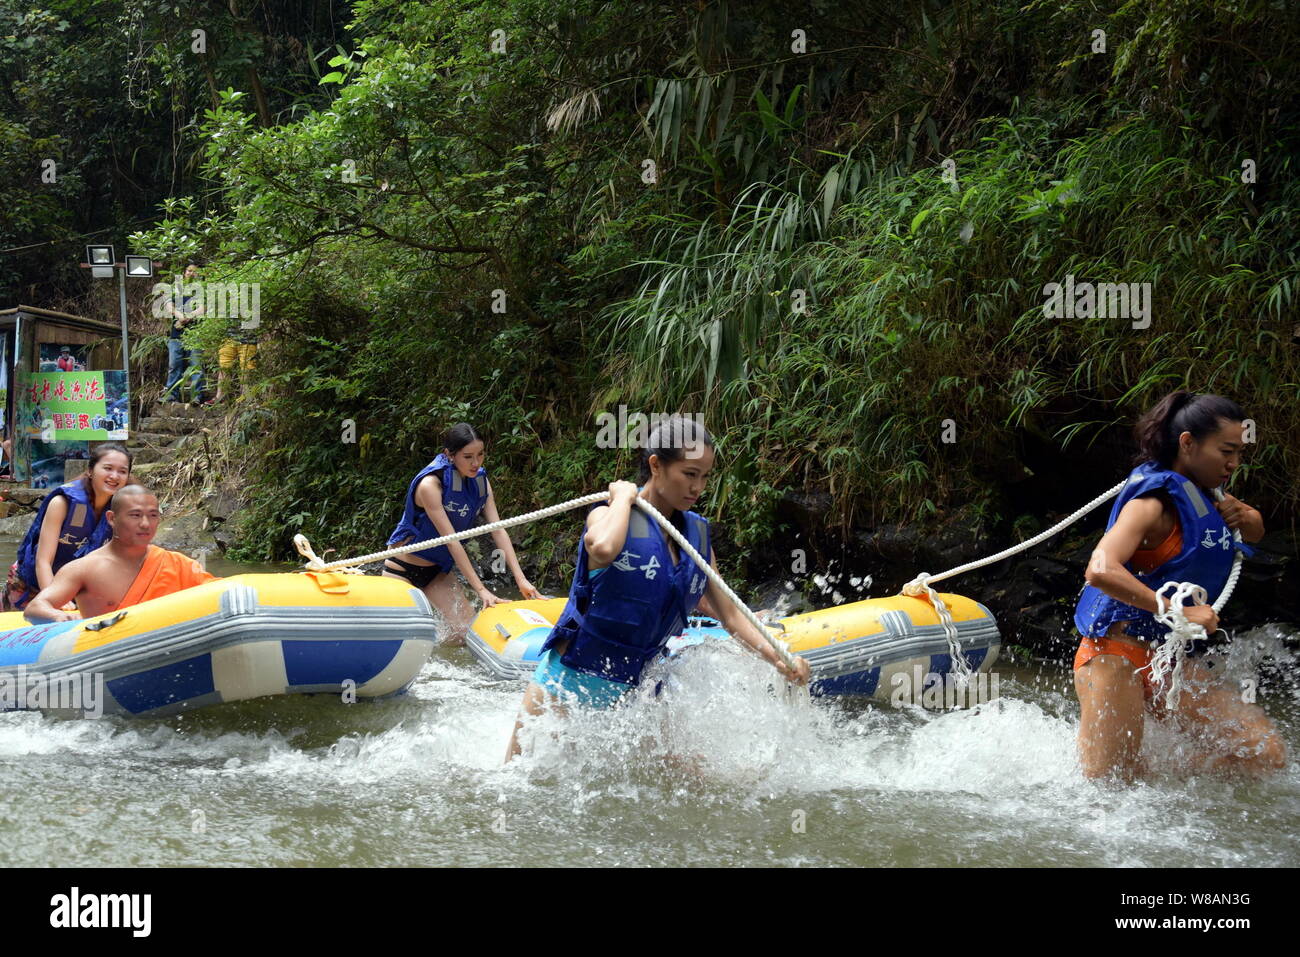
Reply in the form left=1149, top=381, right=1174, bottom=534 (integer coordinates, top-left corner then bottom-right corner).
left=1074, top=390, right=1287, bottom=779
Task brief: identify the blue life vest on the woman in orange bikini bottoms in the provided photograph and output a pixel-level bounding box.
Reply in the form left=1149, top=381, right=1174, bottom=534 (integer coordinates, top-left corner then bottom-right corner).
left=1074, top=462, right=1252, bottom=641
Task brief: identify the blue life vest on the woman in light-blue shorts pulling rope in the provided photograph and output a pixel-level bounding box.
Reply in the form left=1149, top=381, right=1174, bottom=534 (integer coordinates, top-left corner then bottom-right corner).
left=542, top=506, right=711, bottom=685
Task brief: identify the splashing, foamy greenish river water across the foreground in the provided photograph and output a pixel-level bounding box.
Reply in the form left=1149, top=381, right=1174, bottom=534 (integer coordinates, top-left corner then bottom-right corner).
left=0, top=530, right=1300, bottom=867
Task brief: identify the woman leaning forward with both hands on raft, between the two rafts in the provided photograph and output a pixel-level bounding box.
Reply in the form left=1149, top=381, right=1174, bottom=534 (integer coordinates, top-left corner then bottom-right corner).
left=384, top=423, right=542, bottom=645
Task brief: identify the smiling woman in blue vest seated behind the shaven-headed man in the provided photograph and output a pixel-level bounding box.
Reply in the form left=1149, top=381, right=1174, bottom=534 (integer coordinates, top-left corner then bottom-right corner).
left=5, top=442, right=131, bottom=610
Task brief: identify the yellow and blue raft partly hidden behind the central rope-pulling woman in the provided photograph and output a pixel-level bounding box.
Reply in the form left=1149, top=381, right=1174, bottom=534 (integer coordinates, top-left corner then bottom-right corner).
left=467, top=594, right=1001, bottom=701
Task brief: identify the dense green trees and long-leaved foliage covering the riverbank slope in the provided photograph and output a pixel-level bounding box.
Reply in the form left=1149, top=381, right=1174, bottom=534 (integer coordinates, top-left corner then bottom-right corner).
left=0, top=0, right=1300, bottom=572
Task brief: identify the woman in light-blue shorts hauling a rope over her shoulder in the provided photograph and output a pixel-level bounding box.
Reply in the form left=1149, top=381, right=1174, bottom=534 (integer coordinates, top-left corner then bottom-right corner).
left=506, top=416, right=809, bottom=762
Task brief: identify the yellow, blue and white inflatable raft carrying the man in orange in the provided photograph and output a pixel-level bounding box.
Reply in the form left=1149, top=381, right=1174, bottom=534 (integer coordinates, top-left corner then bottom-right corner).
left=0, top=573, right=437, bottom=716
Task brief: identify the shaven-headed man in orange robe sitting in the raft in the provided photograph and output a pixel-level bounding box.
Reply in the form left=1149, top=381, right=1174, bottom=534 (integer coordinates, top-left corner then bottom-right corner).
left=23, top=485, right=217, bottom=624
